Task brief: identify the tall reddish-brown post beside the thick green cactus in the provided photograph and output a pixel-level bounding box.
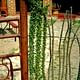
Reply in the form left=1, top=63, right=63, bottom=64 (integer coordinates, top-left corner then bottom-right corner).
left=20, top=0, right=28, bottom=80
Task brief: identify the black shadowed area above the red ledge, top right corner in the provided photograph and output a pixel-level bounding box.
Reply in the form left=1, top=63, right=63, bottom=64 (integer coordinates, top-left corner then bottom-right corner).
left=53, top=0, right=80, bottom=14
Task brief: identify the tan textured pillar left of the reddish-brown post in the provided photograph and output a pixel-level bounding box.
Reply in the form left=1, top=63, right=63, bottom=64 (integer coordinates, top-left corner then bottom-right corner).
left=7, top=0, right=16, bottom=16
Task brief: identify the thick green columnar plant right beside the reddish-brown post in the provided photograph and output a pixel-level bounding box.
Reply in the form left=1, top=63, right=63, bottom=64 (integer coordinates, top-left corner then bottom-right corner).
left=29, top=0, right=47, bottom=80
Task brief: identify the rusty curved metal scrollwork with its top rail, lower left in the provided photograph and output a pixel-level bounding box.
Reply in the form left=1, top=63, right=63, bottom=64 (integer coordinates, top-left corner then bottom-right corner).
left=0, top=53, right=21, bottom=80
